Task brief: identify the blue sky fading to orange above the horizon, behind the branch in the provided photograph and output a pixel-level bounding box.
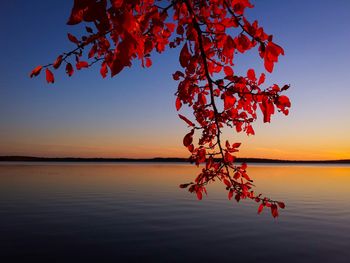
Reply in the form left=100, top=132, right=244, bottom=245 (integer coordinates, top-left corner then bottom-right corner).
left=0, top=0, right=350, bottom=160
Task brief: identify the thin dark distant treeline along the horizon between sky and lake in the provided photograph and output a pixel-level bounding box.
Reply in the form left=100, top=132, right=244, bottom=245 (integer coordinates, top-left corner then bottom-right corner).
left=0, top=156, right=350, bottom=164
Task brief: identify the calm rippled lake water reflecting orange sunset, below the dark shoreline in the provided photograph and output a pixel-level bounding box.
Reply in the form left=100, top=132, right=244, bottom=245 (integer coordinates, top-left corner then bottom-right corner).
left=0, top=163, right=350, bottom=263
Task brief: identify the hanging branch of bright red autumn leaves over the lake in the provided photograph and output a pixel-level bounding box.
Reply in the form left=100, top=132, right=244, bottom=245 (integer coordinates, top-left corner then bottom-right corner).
left=30, top=0, right=291, bottom=217
